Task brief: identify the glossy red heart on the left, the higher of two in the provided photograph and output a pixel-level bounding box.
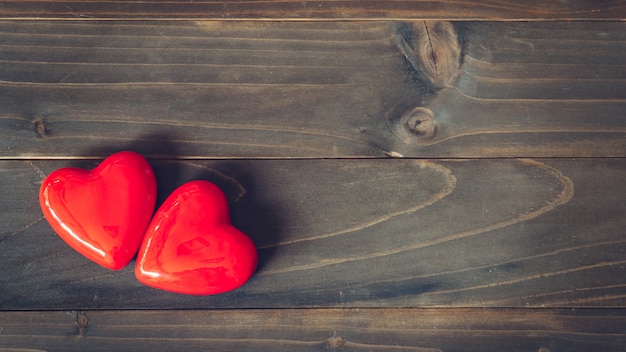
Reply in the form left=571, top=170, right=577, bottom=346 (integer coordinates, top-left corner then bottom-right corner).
left=39, top=152, right=157, bottom=270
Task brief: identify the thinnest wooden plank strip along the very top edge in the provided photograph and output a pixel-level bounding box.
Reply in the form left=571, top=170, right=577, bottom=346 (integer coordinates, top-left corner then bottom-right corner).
left=0, top=0, right=626, bottom=21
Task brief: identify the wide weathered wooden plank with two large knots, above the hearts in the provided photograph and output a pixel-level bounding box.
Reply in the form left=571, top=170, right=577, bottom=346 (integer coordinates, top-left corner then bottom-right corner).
left=0, top=20, right=626, bottom=159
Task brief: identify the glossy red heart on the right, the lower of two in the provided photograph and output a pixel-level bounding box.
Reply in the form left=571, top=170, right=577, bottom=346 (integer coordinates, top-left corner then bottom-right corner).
left=135, top=181, right=258, bottom=295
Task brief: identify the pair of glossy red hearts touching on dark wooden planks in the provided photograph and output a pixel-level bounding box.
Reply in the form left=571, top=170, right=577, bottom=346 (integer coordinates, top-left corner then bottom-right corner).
left=39, top=151, right=258, bottom=295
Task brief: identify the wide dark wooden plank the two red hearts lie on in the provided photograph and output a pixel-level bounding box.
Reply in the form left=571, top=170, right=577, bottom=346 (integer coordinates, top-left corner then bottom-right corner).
left=0, top=158, right=626, bottom=310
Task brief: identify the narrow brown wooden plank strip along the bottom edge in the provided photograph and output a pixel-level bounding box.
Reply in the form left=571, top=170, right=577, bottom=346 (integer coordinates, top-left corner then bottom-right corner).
left=0, top=309, right=626, bottom=352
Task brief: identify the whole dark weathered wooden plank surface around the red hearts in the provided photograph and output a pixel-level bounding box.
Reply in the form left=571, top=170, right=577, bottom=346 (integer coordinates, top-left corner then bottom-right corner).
left=0, top=0, right=626, bottom=352
